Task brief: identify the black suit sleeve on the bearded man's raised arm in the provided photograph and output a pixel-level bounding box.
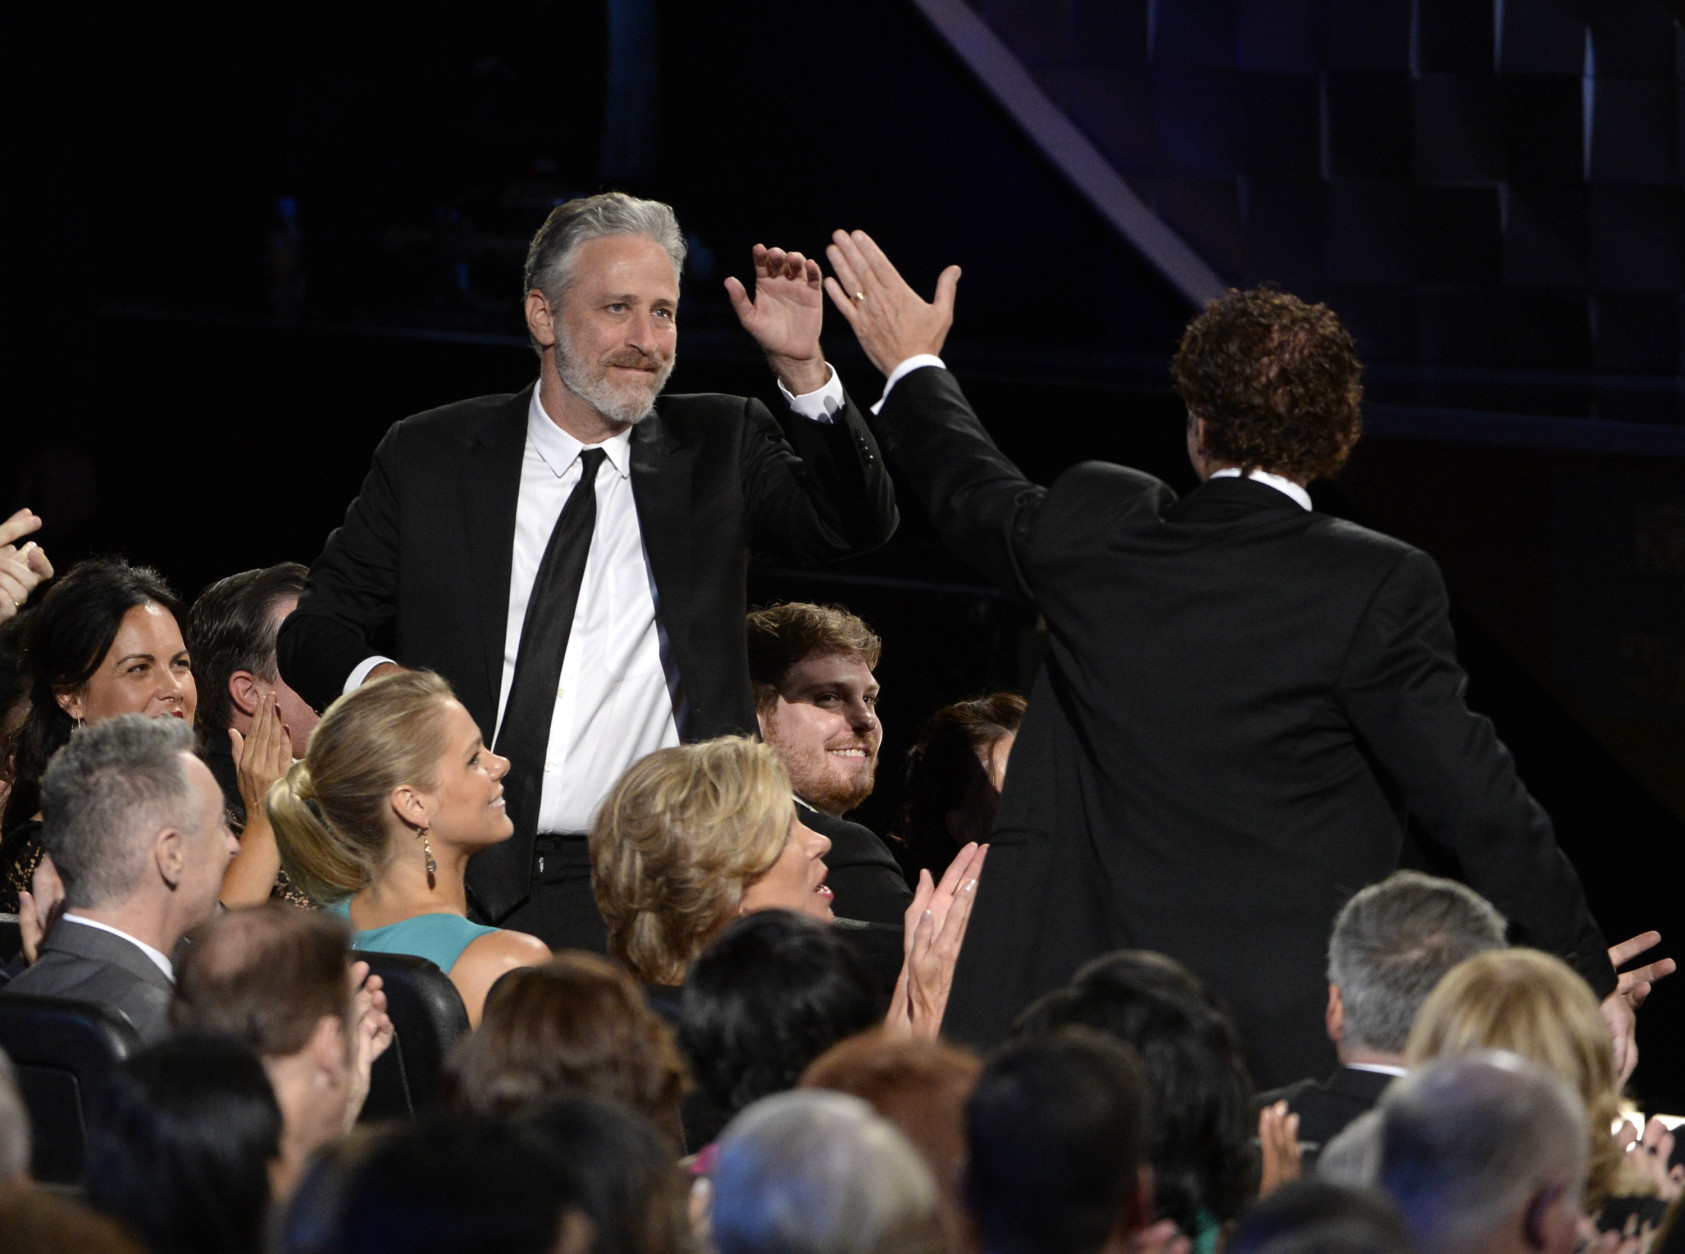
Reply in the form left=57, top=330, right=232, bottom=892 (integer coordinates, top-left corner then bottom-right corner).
left=743, top=387, right=900, bottom=561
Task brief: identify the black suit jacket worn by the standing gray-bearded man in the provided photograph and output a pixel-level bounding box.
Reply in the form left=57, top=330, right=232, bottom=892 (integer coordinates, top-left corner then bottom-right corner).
left=276, top=386, right=896, bottom=919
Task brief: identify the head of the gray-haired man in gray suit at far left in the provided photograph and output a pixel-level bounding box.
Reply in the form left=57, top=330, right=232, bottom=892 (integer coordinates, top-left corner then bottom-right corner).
left=40, top=715, right=234, bottom=923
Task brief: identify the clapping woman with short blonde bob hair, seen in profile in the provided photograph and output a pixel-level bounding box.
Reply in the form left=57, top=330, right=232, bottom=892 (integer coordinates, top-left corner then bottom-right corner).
left=590, top=737, right=987, bottom=1037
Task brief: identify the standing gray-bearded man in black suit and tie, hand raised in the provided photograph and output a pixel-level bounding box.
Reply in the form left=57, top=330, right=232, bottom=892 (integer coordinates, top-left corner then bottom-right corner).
left=278, top=192, right=896, bottom=949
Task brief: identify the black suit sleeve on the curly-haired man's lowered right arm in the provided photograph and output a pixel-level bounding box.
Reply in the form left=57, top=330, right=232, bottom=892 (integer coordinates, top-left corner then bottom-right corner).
left=1340, top=551, right=1616, bottom=998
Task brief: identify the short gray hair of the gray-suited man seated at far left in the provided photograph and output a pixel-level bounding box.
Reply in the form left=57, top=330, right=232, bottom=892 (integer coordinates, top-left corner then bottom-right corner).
left=40, top=715, right=199, bottom=907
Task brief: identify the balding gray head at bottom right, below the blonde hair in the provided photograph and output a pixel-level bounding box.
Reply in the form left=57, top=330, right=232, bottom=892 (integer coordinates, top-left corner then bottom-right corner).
left=1375, top=1050, right=1587, bottom=1254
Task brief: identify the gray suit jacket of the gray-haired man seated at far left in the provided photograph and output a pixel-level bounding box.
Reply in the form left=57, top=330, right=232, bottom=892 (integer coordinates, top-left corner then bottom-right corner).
left=0, top=919, right=175, bottom=1043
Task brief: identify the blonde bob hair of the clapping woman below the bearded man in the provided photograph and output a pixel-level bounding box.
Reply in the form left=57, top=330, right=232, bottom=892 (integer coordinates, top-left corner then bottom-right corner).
left=590, top=737, right=812, bottom=984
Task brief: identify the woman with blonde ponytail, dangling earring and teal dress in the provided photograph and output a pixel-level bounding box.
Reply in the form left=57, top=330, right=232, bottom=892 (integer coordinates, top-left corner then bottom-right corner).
left=266, top=671, right=549, bottom=1025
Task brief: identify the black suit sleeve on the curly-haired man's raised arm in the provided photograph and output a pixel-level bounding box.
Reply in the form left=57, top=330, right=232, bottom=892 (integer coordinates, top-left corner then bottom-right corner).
left=878, top=366, right=1048, bottom=597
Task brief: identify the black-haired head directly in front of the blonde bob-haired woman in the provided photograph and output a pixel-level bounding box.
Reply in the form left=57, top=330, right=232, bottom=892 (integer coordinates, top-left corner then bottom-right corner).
left=679, top=910, right=883, bottom=1117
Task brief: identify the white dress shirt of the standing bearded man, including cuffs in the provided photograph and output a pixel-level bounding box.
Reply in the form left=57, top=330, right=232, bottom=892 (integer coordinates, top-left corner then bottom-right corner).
left=345, top=367, right=843, bottom=833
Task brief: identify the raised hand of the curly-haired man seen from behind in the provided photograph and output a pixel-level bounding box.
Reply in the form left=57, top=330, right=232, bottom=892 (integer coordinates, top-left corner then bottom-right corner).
left=826, top=231, right=959, bottom=374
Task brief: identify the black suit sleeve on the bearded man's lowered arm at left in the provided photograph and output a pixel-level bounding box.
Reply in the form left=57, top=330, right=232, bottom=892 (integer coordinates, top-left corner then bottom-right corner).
left=275, top=423, right=403, bottom=710
